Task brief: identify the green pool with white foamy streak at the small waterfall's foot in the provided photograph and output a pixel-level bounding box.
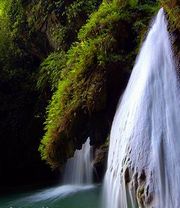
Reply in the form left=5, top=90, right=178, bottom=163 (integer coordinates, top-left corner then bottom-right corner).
left=0, top=185, right=101, bottom=208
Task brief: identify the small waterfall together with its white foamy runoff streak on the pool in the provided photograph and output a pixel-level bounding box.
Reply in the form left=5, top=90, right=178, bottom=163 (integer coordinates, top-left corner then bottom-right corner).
left=12, top=138, right=95, bottom=204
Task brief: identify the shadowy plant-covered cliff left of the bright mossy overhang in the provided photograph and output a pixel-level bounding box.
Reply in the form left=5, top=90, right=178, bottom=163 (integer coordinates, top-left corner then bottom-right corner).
left=0, top=0, right=100, bottom=188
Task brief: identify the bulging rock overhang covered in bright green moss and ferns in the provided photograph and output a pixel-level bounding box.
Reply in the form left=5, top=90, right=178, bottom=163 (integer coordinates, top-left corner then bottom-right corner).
left=40, top=1, right=158, bottom=167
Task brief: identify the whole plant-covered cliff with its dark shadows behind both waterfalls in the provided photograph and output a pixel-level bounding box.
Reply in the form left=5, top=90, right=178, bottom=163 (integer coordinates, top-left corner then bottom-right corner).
left=0, top=0, right=180, bottom=186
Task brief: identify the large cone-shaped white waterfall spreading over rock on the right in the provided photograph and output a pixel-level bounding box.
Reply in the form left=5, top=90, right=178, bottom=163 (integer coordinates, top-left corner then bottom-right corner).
left=103, top=9, right=180, bottom=208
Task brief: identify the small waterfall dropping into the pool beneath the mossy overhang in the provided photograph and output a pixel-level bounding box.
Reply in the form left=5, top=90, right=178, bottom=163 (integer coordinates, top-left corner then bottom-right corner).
left=63, top=138, right=93, bottom=184
